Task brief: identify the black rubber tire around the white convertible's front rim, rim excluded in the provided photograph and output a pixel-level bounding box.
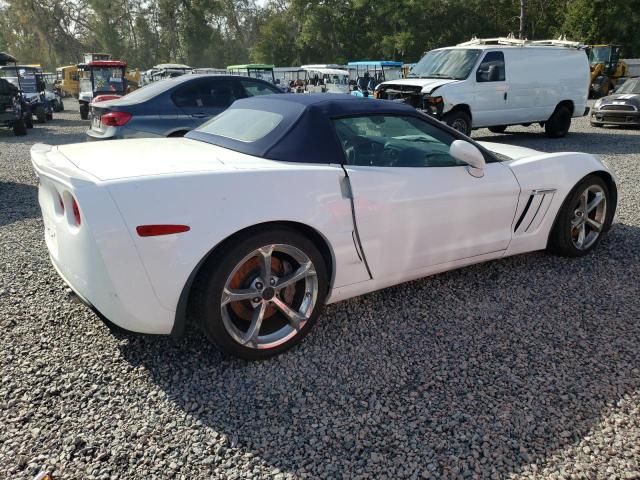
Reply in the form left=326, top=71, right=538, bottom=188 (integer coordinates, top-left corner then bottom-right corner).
left=547, top=174, right=615, bottom=257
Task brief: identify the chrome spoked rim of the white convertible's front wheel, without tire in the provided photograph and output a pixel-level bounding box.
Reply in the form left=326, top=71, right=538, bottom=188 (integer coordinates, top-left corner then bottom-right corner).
left=571, top=185, right=607, bottom=250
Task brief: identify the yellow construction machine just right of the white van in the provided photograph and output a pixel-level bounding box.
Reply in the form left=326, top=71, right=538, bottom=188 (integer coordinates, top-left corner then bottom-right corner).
left=587, top=45, right=627, bottom=98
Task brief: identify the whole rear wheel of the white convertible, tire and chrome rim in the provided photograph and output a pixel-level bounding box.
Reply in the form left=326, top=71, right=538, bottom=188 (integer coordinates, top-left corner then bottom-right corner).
left=192, top=228, right=328, bottom=360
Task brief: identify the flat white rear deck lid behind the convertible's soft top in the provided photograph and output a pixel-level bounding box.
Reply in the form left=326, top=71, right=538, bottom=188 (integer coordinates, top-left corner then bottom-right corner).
left=57, top=138, right=292, bottom=181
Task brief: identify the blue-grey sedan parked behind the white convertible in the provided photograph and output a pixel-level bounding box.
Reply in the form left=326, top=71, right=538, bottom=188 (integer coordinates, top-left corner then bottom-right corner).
left=87, top=75, right=282, bottom=140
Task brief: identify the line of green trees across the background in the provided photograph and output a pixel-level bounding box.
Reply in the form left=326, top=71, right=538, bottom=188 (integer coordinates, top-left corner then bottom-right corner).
left=0, top=0, right=640, bottom=69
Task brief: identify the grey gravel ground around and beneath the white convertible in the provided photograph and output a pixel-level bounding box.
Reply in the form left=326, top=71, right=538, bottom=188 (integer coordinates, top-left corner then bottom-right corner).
left=0, top=102, right=640, bottom=479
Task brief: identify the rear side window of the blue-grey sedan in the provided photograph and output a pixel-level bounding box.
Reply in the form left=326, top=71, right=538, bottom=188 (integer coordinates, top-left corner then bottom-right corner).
left=172, top=78, right=236, bottom=108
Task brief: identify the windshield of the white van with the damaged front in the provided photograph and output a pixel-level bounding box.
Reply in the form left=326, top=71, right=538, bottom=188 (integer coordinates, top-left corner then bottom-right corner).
left=408, top=49, right=480, bottom=80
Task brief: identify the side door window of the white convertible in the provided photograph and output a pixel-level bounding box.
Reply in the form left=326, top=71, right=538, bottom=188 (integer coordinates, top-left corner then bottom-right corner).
left=334, top=115, right=462, bottom=167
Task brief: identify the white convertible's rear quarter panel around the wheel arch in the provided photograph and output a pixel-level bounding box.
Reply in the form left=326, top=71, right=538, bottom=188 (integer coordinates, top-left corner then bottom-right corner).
left=109, top=164, right=369, bottom=309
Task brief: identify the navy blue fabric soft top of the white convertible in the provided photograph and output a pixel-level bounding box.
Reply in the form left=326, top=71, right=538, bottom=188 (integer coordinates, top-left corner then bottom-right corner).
left=186, top=93, right=428, bottom=163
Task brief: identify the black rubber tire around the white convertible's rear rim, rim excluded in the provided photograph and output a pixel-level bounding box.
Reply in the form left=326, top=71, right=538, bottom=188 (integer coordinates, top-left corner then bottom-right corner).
left=190, top=227, right=328, bottom=360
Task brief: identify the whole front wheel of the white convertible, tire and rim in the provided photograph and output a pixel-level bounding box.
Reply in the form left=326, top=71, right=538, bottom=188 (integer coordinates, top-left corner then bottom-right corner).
left=549, top=175, right=615, bottom=257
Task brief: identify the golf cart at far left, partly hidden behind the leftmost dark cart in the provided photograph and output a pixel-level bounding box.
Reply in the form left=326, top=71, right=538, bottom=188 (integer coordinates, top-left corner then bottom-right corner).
left=0, top=63, right=53, bottom=126
